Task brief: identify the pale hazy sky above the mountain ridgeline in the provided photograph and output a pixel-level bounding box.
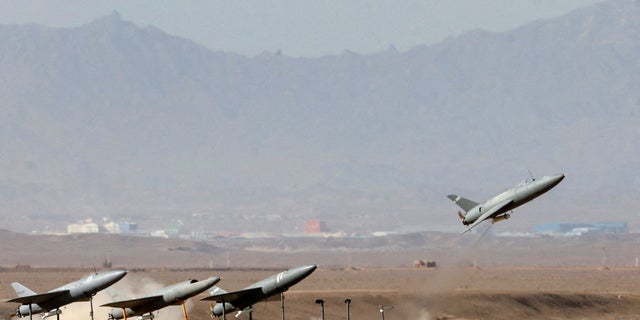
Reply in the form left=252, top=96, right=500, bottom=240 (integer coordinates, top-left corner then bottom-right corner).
left=0, top=0, right=602, bottom=57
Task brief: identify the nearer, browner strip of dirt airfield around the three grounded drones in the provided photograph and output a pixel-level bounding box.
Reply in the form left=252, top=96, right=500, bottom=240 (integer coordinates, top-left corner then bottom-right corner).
left=0, top=267, right=640, bottom=320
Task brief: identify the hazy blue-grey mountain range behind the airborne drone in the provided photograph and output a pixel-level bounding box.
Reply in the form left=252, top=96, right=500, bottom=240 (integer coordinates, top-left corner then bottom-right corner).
left=0, top=0, right=640, bottom=233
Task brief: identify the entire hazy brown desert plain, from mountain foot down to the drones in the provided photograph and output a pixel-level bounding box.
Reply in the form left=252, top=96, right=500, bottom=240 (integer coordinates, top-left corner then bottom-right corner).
left=0, top=233, right=640, bottom=320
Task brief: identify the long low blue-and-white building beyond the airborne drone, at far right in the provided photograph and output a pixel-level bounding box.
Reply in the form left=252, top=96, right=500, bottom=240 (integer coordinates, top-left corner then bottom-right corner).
left=533, top=222, right=629, bottom=236
